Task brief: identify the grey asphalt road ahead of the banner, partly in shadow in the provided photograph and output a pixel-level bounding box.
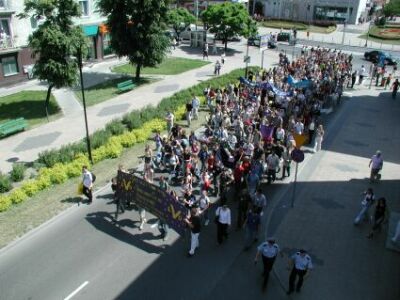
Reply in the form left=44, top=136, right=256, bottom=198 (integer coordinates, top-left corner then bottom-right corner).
left=0, top=40, right=398, bottom=300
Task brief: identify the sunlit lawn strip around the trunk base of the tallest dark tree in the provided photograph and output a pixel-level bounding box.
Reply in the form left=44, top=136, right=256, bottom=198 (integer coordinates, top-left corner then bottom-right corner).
left=112, top=57, right=210, bottom=75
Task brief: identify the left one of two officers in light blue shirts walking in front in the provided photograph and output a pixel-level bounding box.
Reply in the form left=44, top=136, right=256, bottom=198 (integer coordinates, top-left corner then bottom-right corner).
left=254, top=237, right=283, bottom=290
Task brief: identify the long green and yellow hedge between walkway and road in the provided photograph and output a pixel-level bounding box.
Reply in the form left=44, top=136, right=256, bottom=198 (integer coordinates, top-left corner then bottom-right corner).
left=0, top=68, right=258, bottom=212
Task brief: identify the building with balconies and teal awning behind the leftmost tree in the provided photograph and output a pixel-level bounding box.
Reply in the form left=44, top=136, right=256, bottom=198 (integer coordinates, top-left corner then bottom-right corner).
left=0, top=0, right=113, bottom=86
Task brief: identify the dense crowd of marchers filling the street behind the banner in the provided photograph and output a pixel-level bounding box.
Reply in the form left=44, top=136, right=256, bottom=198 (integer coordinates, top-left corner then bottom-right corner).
left=80, top=48, right=396, bottom=293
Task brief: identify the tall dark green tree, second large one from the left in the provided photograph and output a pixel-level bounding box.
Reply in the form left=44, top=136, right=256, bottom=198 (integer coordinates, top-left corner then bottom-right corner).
left=98, top=0, right=170, bottom=79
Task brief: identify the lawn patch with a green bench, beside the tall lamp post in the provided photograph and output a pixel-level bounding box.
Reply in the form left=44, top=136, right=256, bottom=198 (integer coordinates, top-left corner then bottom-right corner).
left=75, top=76, right=156, bottom=106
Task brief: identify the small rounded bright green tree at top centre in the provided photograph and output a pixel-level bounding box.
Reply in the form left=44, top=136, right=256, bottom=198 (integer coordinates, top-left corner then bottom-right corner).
left=202, top=2, right=257, bottom=51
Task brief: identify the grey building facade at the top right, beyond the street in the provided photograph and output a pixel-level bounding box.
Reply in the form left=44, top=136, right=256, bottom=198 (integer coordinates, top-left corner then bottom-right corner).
left=264, top=0, right=369, bottom=24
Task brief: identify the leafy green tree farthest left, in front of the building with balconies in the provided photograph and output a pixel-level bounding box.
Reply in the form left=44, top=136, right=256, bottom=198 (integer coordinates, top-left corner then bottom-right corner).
left=18, top=0, right=86, bottom=119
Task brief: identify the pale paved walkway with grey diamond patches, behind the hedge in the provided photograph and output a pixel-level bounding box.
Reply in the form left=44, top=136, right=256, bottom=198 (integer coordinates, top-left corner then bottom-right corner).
left=0, top=42, right=268, bottom=172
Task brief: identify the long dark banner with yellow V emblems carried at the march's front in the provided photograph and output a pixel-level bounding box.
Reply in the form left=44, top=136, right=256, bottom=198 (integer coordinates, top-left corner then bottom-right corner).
left=117, top=171, right=187, bottom=235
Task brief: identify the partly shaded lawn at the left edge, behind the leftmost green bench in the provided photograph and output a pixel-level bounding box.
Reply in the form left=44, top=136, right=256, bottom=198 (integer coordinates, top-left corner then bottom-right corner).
left=0, top=91, right=60, bottom=126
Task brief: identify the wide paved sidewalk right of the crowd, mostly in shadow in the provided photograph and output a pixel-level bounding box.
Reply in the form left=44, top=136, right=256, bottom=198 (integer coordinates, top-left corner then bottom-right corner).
left=266, top=89, right=400, bottom=300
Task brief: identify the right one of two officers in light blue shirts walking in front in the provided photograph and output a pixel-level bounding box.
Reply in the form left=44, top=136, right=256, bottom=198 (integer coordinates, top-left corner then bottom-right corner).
left=286, top=249, right=313, bottom=295
